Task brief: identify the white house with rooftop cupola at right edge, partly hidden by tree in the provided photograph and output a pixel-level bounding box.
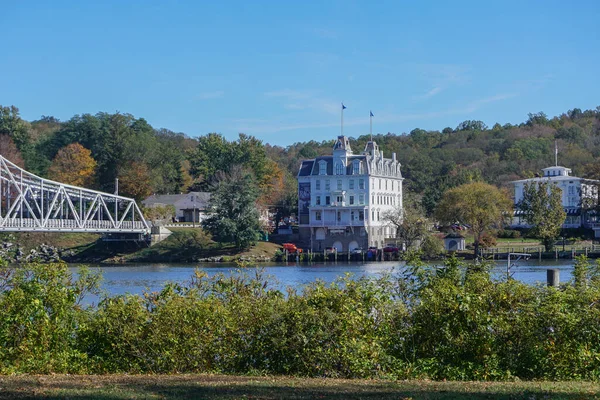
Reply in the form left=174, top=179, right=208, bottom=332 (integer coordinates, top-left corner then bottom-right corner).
left=512, top=165, right=600, bottom=228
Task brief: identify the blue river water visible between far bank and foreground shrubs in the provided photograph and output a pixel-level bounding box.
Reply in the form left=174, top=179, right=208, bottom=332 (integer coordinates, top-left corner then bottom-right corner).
left=70, top=260, right=573, bottom=302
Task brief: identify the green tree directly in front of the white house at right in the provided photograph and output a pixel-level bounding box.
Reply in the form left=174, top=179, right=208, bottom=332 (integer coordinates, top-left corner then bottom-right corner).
left=517, top=182, right=567, bottom=251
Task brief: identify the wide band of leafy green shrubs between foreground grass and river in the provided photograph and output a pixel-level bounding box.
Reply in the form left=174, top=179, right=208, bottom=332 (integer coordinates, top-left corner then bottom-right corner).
left=0, top=254, right=600, bottom=381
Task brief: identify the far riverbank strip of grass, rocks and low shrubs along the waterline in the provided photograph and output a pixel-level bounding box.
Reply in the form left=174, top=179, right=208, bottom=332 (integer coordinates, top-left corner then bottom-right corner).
left=0, top=228, right=600, bottom=264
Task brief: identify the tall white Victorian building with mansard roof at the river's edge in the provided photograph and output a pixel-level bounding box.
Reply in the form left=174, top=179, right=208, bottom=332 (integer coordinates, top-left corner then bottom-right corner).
left=298, top=136, right=403, bottom=252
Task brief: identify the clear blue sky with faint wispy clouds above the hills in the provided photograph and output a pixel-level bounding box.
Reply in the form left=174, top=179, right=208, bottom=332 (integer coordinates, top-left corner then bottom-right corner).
left=0, top=0, right=600, bottom=146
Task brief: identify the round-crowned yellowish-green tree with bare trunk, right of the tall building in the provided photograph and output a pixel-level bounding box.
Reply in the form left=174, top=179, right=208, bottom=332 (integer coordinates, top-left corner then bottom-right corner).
left=436, top=182, right=512, bottom=257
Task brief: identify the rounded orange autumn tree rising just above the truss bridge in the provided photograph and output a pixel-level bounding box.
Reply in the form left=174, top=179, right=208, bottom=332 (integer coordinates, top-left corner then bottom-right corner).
left=48, top=143, right=96, bottom=187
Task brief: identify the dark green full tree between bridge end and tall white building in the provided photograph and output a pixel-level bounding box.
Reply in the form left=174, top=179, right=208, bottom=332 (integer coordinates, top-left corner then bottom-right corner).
left=202, top=166, right=260, bottom=249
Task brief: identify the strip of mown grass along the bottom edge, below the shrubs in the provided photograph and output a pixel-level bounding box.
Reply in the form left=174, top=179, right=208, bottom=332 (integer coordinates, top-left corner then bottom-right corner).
left=0, top=375, right=600, bottom=400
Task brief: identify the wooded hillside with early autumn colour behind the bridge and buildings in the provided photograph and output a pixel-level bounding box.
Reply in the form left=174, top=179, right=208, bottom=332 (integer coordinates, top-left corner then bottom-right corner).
left=0, top=106, right=600, bottom=213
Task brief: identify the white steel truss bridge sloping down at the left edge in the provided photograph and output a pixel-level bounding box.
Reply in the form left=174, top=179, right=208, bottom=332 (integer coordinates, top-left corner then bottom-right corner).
left=0, top=155, right=150, bottom=234
